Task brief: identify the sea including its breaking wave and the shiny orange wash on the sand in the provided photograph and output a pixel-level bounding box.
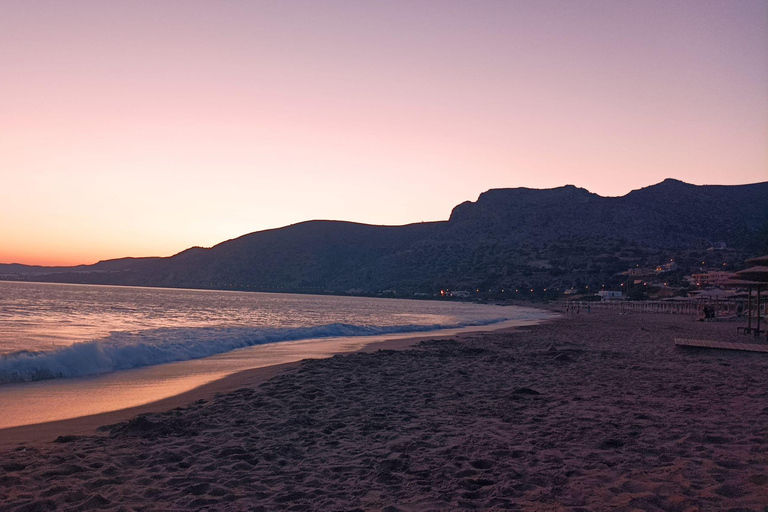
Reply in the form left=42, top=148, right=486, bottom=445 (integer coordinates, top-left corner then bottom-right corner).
left=0, top=282, right=550, bottom=428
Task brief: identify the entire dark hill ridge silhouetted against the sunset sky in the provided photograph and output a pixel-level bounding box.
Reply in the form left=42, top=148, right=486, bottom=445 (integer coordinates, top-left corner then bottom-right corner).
left=6, top=179, right=768, bottom=295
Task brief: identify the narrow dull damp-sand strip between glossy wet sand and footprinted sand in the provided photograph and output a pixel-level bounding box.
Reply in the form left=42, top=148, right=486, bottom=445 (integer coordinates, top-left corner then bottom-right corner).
left=0, top=318, right=544, bottom=450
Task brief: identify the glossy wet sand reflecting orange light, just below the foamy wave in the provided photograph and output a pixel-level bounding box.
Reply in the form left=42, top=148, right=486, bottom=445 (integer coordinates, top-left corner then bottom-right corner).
left=0, top=318, right=549, bottom=430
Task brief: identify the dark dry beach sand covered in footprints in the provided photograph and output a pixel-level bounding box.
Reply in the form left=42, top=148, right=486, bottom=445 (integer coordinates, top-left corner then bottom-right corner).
left=0, top=311, right=768, bottom=511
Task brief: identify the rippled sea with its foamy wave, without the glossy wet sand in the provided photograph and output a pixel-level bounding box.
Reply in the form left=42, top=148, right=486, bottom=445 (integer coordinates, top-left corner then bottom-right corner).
left=0, top=282, right=547, bottom=384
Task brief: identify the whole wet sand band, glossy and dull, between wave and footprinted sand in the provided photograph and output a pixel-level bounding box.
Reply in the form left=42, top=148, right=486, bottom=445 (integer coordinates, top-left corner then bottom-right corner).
left=0, top=320, right=543, bottom=450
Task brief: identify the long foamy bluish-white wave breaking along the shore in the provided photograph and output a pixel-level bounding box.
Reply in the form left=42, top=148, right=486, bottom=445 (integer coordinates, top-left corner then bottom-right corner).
left=0, top=318, right=507, bottom=384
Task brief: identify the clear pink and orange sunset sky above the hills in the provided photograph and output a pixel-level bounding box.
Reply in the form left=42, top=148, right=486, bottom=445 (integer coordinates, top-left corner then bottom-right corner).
left=0, top=0, right=768, bottom=265
